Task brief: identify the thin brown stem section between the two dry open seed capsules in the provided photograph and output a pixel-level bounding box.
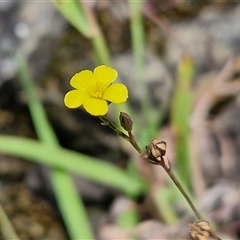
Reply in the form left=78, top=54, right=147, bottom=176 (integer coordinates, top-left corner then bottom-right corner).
left=161, top=161, right=203, bottom=220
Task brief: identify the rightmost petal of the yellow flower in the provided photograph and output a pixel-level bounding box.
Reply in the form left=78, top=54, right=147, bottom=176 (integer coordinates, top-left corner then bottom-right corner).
left=103, top=83, right=128, bottom=103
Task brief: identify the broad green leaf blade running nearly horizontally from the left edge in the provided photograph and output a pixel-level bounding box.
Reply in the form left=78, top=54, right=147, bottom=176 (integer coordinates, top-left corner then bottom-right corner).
left=0, top=135, right=146, bottom=197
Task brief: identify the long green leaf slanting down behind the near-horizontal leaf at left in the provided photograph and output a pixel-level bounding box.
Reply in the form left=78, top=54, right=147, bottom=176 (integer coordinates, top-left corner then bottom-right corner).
left=15, top=55, right=93, bottom=239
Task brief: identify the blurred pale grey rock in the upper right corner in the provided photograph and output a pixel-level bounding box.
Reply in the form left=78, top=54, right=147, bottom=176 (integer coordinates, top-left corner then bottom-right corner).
left=166, top=5, right=240, bottom=71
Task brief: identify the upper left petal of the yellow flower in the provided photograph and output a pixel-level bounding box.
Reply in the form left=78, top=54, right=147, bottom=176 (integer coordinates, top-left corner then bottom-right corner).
left=70, top=70, right=95, bottom=90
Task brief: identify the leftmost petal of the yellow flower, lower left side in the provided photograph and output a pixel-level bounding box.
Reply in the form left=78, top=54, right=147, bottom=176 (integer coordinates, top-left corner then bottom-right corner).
left=64, top=90, right=86, bottom=108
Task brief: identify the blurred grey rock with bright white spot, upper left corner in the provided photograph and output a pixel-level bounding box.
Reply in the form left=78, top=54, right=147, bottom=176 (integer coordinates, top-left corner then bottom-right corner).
left=0, top=1, right=66, bottom=84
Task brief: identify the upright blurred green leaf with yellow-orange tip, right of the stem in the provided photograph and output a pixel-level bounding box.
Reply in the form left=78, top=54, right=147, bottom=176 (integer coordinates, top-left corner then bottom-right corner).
left=171, top=56, right=194, bottom=187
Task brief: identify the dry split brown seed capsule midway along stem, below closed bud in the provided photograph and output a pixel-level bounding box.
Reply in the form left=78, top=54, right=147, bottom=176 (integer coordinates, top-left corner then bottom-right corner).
left=146, top=139, right=167, bottom=163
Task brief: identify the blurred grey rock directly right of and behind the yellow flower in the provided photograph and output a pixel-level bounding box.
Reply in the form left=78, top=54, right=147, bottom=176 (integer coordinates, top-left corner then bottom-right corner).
left=113, top=51, right=173, bottom=111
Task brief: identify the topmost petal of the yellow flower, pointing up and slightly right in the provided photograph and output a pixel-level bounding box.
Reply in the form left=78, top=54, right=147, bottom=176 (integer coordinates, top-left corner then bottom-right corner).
left=94, top=65, right=118, bottom=93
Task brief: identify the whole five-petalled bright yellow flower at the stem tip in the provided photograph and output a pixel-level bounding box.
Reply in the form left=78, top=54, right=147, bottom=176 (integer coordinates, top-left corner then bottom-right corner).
left=64, top=65, right=128, bottom=116
